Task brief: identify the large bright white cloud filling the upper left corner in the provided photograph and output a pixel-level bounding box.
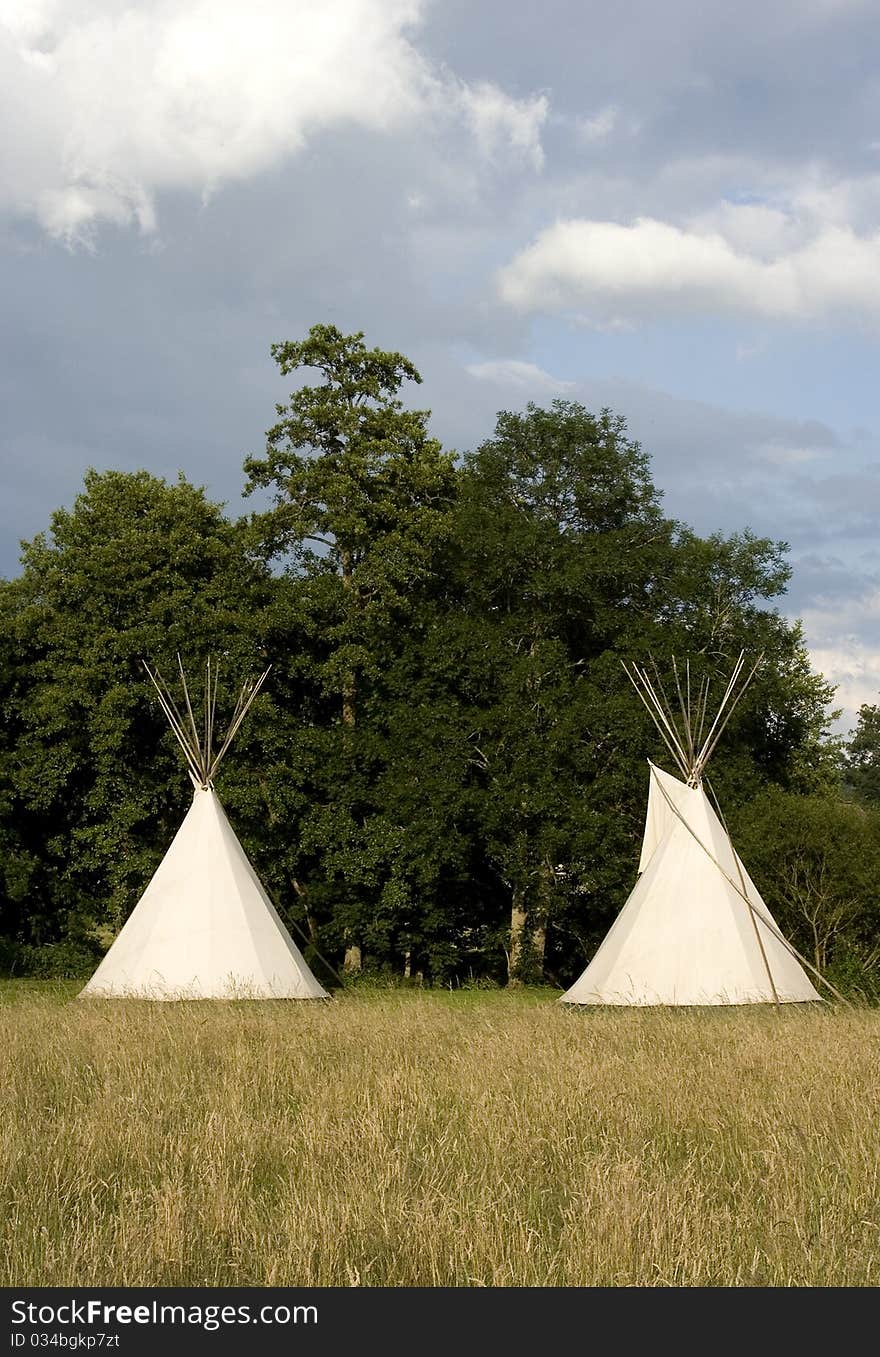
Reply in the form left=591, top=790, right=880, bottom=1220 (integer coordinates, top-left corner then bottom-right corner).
left=0, top=0, right=547, bottom=240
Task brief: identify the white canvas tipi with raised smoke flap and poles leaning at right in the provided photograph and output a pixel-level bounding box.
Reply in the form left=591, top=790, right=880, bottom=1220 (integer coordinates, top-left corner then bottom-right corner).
left=562, top=655, right=819, bottom=1006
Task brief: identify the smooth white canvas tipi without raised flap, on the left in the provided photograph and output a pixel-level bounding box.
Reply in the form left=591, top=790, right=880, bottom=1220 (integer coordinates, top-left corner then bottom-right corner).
left=81, top=666, right=327, bottom=999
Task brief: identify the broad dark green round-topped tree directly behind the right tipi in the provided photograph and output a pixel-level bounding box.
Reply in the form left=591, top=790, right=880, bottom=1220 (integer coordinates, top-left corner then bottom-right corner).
left=456, top=400, right=830, bottom=977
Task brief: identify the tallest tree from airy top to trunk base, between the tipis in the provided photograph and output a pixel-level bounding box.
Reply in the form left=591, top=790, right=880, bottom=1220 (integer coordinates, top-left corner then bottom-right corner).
left=244, top=326, right=455, bottom=969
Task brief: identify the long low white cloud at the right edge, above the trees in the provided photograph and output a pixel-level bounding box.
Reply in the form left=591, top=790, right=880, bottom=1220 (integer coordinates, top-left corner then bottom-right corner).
left=498, top=205, right=880, bottom=319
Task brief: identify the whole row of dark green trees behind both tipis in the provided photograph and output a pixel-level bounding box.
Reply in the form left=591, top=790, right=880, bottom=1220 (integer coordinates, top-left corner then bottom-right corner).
left=0, top=326, right=863, bottom=984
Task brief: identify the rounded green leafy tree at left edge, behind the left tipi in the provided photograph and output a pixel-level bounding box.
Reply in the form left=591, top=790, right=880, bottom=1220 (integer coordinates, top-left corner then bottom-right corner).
left=0, top=471, right=270, bottom=944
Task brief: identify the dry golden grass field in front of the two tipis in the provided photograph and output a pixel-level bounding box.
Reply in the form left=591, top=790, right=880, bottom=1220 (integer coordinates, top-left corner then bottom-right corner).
left=0, top=982, right=880, bottom=1286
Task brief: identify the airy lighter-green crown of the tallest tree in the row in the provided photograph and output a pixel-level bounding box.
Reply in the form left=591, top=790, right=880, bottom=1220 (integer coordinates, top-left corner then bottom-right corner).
left=244, top=326, right=454, bottom=726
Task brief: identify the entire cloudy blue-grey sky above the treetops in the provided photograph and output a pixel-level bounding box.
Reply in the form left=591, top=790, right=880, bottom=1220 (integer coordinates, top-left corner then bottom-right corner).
left=0, top=0, right=880, bottom=725
